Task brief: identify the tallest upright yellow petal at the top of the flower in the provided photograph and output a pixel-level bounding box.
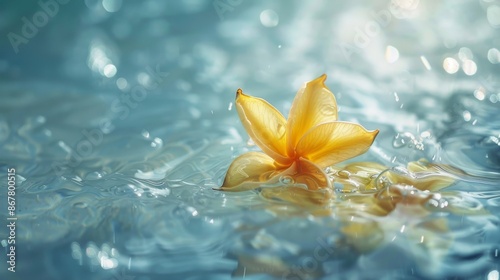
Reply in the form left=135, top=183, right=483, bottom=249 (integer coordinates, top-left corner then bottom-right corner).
left=287, top=74, right=337, bottom=155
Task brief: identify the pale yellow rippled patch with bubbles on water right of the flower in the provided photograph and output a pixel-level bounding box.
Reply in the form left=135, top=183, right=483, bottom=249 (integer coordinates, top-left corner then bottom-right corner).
left=331, top=160, right=486, bottom=216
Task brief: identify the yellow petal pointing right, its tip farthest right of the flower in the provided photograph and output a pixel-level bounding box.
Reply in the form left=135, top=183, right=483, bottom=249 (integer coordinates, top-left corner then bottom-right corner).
left=296, top=121, right=378, bottom=168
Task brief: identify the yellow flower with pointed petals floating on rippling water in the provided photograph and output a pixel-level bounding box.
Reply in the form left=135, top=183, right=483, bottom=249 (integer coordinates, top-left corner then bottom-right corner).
left=220, top=75, right=378, bottom=192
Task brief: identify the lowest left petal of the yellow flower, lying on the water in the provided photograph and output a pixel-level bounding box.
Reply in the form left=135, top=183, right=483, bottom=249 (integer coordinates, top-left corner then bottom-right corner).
left=217, top=152, right=276, bottom=191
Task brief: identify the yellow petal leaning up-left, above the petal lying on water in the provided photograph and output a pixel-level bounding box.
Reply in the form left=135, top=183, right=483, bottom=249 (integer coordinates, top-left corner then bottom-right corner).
left=236, top=89, right=290, bottom=165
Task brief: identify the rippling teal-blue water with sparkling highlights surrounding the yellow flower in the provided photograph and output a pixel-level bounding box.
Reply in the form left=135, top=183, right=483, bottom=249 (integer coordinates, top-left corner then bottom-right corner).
left=0, top=0, right=500, bottom=280
